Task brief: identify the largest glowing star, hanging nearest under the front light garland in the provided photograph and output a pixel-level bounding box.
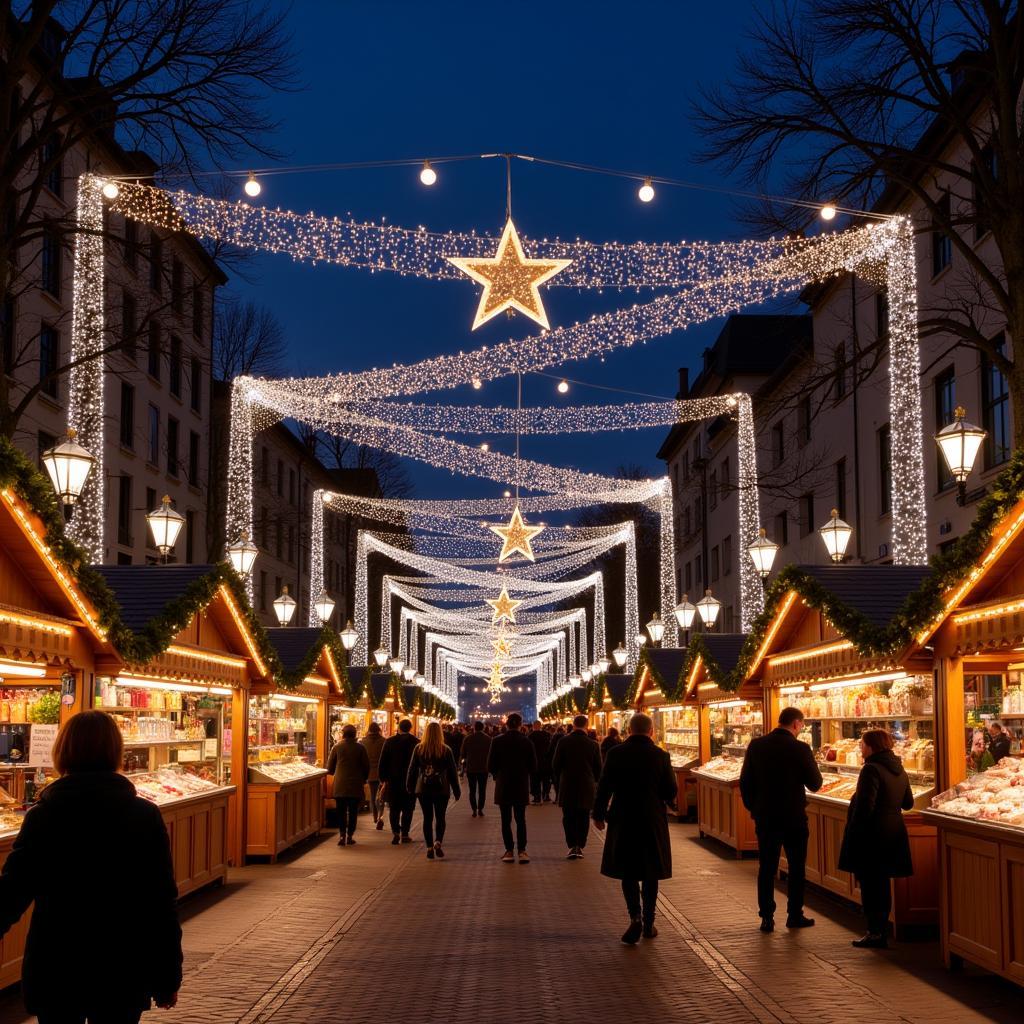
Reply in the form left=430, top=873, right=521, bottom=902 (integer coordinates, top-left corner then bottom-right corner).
left=447, top=217, right=572, bottom=331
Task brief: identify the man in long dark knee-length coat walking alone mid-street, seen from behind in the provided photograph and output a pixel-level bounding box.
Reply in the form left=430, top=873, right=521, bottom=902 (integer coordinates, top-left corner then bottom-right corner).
left=589, top=715, right=676, bottom=945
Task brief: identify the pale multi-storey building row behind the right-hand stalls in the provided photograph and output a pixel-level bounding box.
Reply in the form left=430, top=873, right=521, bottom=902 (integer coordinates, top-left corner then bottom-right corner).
left=658, top=74, right=1013, bottom=608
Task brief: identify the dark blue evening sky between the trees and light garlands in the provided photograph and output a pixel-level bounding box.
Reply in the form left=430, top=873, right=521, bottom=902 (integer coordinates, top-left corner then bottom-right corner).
left=231, top=0, right=790, bottom=497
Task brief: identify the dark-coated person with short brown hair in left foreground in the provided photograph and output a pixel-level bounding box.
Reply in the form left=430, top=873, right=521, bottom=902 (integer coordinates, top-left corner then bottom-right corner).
left=0, top=711, right=181, bottom=1024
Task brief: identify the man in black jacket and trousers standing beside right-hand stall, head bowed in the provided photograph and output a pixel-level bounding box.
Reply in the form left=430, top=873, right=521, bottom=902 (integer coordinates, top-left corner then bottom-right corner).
left=739, top=708, right=821, bottom=932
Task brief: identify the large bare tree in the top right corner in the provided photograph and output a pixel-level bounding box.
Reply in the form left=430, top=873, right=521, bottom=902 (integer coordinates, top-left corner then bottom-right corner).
left=696, top=0, right=1024, bottom=445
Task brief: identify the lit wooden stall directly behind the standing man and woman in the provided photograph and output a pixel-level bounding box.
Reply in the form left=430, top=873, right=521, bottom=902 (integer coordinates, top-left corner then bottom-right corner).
left=743, top=565, right=938, bottom=932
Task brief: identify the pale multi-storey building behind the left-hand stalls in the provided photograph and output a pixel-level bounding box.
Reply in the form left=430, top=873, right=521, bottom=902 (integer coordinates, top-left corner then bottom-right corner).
left=0, top=16, right=226, bottom=564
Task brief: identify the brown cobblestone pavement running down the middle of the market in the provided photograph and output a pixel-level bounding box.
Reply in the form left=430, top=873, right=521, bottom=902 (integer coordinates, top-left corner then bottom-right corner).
left=0, top=801, right=1024, bottom=1024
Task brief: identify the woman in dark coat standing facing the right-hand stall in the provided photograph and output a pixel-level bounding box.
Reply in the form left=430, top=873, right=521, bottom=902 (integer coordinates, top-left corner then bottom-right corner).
left=839, top=729, right=913, bottom=949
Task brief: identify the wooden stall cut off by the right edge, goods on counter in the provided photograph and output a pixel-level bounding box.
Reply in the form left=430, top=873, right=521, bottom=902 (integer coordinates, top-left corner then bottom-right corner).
left=918, top=491, right=1024, bottom=985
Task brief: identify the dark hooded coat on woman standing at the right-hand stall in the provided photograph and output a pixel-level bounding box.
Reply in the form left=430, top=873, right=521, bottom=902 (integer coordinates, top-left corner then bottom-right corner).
left=839, top=751, right=913, bottom=879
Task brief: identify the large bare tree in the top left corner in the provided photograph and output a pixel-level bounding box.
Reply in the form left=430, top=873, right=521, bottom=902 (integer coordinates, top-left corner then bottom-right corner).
left=0, top=0, right=294, bottom=436
